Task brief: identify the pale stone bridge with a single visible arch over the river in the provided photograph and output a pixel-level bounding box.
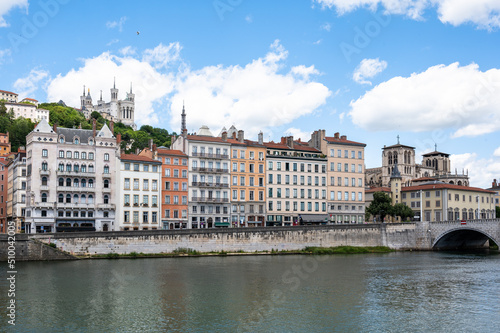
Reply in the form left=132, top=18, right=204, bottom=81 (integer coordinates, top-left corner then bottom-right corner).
left=415, top=219, right=500, bottom=250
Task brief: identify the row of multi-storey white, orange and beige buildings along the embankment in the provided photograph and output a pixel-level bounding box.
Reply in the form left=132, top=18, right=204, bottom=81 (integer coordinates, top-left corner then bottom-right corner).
left=0, top=102, right=498, bottom=233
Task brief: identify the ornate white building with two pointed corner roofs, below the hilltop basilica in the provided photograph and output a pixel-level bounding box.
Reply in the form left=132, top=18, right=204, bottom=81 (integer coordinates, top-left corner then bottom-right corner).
left=25, top=119, right=117, bottom=233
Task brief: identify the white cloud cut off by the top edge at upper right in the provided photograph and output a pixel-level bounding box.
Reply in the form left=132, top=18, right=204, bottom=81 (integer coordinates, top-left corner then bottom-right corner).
left=313, top=0, right=500, bottom=30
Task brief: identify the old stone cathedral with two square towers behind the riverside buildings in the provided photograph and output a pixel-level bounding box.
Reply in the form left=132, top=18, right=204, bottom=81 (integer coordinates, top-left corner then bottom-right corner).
left=365, top=138, right=469, bottom=188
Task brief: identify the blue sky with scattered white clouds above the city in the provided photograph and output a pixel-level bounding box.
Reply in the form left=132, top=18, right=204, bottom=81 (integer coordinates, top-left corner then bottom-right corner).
left=0, top=0, right=500, bottom=188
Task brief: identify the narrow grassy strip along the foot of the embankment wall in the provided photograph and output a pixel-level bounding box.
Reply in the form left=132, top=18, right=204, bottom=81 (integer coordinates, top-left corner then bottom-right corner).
left=82, top=246, right=395, bottom=259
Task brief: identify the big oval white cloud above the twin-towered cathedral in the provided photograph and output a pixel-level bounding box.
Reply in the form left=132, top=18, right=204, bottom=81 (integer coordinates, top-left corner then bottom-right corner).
left=349, top=63, right=500, bottom=137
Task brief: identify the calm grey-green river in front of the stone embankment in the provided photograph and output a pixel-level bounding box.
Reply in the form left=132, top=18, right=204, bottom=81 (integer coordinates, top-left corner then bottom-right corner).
left=0, top=252, right=500, bottom=332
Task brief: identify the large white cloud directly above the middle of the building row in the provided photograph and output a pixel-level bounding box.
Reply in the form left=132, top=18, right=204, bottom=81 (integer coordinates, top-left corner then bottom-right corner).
left=170, top=41, right=331, bottom=137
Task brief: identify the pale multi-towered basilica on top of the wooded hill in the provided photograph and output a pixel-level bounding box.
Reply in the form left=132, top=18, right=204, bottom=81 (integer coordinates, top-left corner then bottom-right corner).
left=80, top=78, right=137, bottom=130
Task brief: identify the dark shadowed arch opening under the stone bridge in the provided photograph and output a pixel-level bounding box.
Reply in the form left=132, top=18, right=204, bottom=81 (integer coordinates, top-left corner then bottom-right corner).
left=432, top=228, right=499, bottom=250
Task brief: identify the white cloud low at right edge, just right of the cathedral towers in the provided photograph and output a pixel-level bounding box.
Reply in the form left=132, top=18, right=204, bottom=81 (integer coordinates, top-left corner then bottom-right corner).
left=450, top=153, right=500, bottom=188
